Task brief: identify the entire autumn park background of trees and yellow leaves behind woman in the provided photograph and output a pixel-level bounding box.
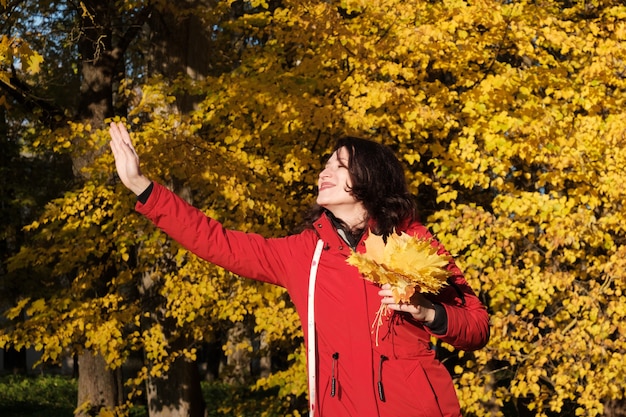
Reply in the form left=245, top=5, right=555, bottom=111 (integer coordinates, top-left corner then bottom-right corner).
left=0, top=0, right=626, bottom=417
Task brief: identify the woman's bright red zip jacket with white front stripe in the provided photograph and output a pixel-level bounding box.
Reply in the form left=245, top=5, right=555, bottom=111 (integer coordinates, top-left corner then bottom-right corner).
left=137, top=183, right=489, bottom=417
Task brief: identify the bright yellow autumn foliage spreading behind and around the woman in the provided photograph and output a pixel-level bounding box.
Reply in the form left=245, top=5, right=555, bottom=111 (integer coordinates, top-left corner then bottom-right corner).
left=3, top=0, right=626, bottom=416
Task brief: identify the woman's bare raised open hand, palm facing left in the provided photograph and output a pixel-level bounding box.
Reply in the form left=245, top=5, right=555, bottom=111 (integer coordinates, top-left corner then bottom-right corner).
left=109, top=122, right=151, bottom=195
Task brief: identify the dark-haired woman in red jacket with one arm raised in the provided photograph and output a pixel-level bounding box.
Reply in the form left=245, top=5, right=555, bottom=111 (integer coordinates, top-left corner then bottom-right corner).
left=110, top=123, right=489, bottom=417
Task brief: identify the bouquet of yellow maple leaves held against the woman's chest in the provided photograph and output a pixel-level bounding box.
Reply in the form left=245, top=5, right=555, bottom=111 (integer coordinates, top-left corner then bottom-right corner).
left=347, top=229, right=450, bottom=344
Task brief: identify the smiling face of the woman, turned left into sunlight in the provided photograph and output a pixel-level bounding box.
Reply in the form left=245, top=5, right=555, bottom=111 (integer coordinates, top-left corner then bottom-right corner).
left=317, top=148, right=361, bottom=214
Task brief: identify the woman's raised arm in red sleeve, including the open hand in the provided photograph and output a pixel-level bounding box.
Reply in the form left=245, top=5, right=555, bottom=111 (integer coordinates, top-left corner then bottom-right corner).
left=109, top=123, right=317, bottom=287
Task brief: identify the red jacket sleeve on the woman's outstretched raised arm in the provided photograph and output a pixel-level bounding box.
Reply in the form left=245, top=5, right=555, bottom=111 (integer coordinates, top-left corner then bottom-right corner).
left=135, top=183, right=314, bottom=287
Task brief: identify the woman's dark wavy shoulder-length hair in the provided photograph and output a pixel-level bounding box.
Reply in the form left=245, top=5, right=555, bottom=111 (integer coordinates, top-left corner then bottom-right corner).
left=305, top=136, right=417, bottom=236
